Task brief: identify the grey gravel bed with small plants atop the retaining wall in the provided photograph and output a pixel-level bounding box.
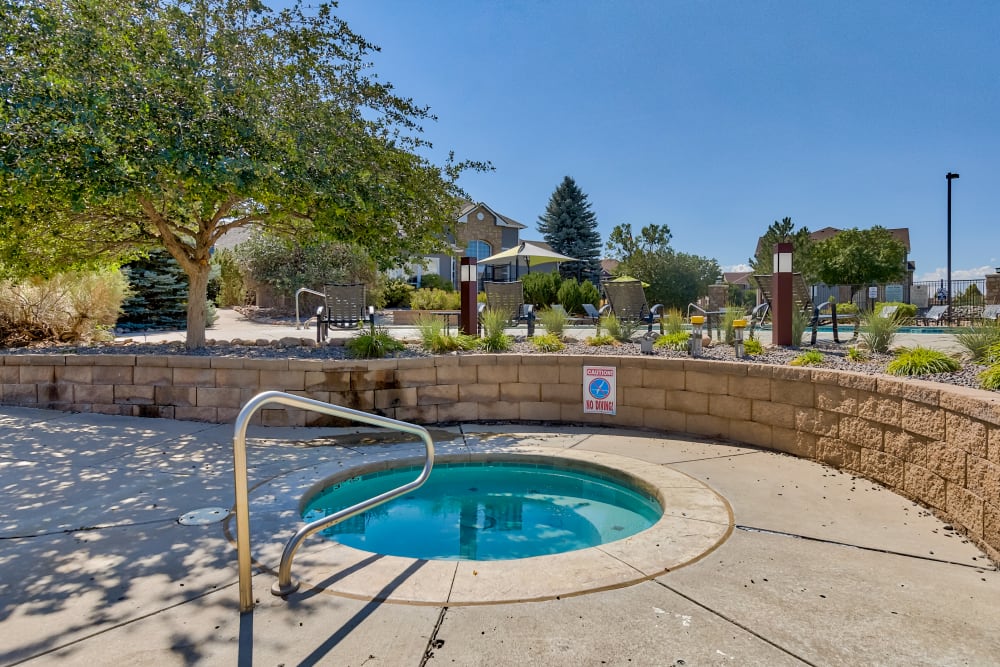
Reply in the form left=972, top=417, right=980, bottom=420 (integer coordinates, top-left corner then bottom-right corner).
left=0, top=336, right=986, bottom=388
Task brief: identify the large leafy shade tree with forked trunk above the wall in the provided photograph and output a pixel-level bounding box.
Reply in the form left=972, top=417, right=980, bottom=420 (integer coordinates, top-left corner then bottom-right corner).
left=0, top=0, right=485, bottom=347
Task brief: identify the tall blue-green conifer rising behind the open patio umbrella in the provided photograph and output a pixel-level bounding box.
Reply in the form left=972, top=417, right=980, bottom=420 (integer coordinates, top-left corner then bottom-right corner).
left=538, top=176, right=601, bottom=284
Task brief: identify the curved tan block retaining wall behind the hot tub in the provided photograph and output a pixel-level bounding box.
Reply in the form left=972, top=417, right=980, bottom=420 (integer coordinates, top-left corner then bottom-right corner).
left=0, top=355, right=1000, bottom=561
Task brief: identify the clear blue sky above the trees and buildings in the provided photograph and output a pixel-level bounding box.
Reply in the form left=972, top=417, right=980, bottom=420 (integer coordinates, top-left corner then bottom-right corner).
left=314, top=0, right=1000, bottom=280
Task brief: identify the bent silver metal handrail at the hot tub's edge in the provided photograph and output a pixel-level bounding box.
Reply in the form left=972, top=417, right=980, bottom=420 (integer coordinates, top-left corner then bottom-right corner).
left=233, top=391, right=434, bottom=612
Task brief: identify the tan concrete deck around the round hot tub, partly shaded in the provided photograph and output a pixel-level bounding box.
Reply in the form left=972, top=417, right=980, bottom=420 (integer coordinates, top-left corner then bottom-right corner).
left=0, top=410, right=1000, bottom=665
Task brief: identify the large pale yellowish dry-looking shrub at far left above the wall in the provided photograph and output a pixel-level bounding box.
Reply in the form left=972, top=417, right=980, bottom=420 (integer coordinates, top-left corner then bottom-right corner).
left=0, top=268, right=129, bottom=347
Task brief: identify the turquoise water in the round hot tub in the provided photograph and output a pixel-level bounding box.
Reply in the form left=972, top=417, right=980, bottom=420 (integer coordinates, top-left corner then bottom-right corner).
left=302, top=462, right=663, bottom=560
